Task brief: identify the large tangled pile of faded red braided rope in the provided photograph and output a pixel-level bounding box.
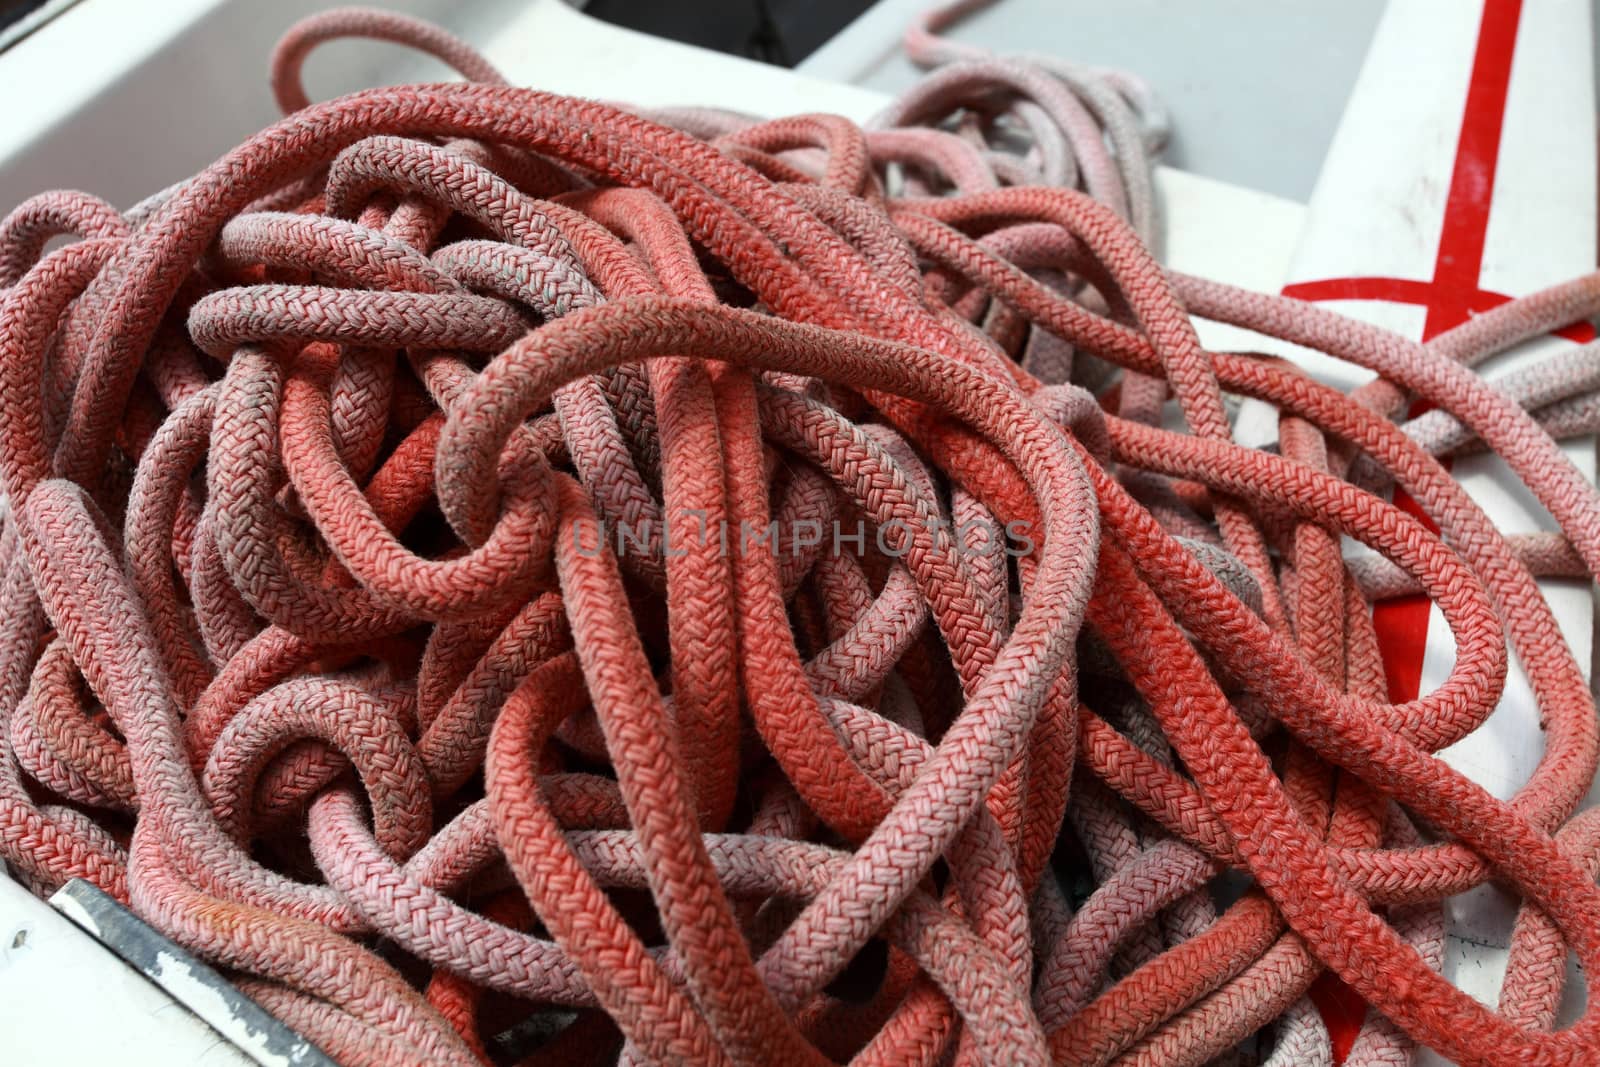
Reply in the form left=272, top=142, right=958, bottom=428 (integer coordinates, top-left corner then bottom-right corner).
left=9, top=3, right=1600, bottom=1065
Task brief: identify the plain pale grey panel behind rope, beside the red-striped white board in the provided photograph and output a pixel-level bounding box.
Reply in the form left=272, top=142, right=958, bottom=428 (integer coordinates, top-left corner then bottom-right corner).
left=798, top=0, right=1384, bottom=203
